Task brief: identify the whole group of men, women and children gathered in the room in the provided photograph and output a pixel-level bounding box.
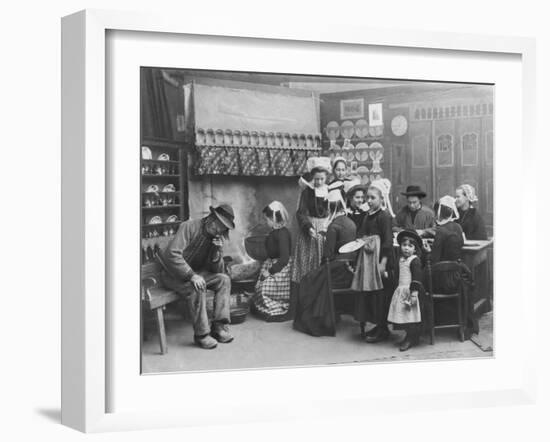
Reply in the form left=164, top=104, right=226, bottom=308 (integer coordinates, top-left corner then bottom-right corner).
left=153, top=157, right=487, bottom=351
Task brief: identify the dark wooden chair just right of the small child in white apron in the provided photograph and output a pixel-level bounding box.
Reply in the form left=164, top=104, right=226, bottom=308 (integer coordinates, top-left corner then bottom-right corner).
left=426, top=255, right=466, bottom=345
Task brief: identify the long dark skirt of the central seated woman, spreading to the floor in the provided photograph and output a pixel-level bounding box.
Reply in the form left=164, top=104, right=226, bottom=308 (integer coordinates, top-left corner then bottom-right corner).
left=294, top=261, right=353, bottom=336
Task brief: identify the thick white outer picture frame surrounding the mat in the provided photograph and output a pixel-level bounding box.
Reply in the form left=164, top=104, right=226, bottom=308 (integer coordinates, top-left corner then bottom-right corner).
left=62, top=10, right=537, bottom=432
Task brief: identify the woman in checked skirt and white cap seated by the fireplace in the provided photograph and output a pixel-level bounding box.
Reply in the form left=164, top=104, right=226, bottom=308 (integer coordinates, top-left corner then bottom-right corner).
left=251, top=201, right=291, bottom=322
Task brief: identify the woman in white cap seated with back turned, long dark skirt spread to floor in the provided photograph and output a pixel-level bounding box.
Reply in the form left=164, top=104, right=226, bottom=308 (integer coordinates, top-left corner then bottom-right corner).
left=294, top=189, right=356, bottom=336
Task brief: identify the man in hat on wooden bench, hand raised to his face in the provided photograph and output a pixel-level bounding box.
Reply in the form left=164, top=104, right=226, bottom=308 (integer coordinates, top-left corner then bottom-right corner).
left=157, top=204, right=235, bottom=349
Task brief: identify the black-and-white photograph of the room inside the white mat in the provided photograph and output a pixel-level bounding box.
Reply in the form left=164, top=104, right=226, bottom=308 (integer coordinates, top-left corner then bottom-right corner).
left=141, top=66, right=495, bottom=374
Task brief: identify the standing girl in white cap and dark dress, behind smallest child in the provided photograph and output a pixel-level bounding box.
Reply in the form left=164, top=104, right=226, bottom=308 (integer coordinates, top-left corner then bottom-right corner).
left=354, top=179, right=394, bottom=343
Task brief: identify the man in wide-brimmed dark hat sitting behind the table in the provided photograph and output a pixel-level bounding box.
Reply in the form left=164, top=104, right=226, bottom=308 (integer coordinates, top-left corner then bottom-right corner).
left=393, top=185, right=435, bottom=236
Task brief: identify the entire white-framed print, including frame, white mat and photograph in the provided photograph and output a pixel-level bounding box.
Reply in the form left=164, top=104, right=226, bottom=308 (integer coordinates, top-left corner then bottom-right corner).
left=62, top=11, right=536, bottom=432
